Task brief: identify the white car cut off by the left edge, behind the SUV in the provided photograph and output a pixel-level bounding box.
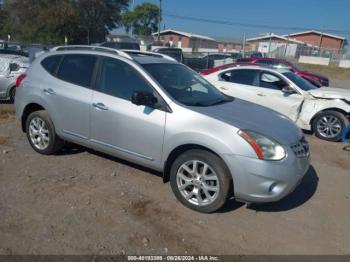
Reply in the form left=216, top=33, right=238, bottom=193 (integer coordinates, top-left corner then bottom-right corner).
left=0, top=53, right=29, bottom=102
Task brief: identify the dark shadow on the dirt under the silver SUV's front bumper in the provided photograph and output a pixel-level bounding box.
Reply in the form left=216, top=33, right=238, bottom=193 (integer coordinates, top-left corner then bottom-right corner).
left=247, top=166, right=319, bottom=212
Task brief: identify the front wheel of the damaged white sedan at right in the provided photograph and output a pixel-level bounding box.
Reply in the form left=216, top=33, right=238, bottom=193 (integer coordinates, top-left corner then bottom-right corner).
left=312, top=110, right=349, bottom=142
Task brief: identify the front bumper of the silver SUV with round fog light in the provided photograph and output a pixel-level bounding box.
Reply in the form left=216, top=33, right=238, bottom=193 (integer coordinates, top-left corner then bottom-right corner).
left=224, top=149, right=310, bottom=203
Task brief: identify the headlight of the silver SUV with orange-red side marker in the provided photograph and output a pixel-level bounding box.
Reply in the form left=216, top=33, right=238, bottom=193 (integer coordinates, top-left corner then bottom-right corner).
left=238, top=130, right=286, bottom=160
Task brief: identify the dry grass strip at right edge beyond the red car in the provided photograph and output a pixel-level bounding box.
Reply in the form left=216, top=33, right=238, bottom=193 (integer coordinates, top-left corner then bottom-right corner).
left=297, top=63, right=350, bottom=81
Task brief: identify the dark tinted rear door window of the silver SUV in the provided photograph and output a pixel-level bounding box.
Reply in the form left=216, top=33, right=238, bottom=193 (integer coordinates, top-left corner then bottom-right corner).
left=57, top=55, right=97, bottom=87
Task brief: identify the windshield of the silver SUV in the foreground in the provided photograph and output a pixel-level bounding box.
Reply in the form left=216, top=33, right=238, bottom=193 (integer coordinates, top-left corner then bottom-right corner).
left=143, top=64, right=232, bottom=106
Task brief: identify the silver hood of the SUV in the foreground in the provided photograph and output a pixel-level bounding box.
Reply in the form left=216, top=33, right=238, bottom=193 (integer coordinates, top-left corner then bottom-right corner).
left=190, top=98, right=302, bottom=145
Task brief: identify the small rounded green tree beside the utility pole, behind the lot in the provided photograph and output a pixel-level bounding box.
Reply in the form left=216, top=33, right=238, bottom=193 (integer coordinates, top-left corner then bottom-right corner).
left=123, top=3, right=159, bottom=35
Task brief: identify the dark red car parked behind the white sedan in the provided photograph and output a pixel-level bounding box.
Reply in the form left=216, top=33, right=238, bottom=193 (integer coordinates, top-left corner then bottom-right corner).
left=238, top=58, right=329, bottom=87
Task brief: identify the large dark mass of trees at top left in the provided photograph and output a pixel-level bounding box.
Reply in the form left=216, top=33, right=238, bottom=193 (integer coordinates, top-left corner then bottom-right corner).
left=2, top=0, right=129, bottom=44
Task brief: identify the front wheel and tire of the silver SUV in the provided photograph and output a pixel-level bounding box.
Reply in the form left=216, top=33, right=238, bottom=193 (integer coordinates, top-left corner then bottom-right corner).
left=170, top=149, right=231, bottom=213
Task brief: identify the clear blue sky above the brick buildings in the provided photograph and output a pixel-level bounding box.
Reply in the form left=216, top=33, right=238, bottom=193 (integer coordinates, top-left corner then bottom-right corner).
left=122, top=0, right=350, bottom=39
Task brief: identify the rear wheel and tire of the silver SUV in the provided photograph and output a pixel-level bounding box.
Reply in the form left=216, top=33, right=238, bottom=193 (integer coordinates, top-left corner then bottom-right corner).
left=26, top=110, right=64, bottom=155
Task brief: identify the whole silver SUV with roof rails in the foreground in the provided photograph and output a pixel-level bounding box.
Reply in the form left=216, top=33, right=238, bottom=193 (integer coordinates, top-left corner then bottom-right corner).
left=15, top=47, right=309, bottom=212
